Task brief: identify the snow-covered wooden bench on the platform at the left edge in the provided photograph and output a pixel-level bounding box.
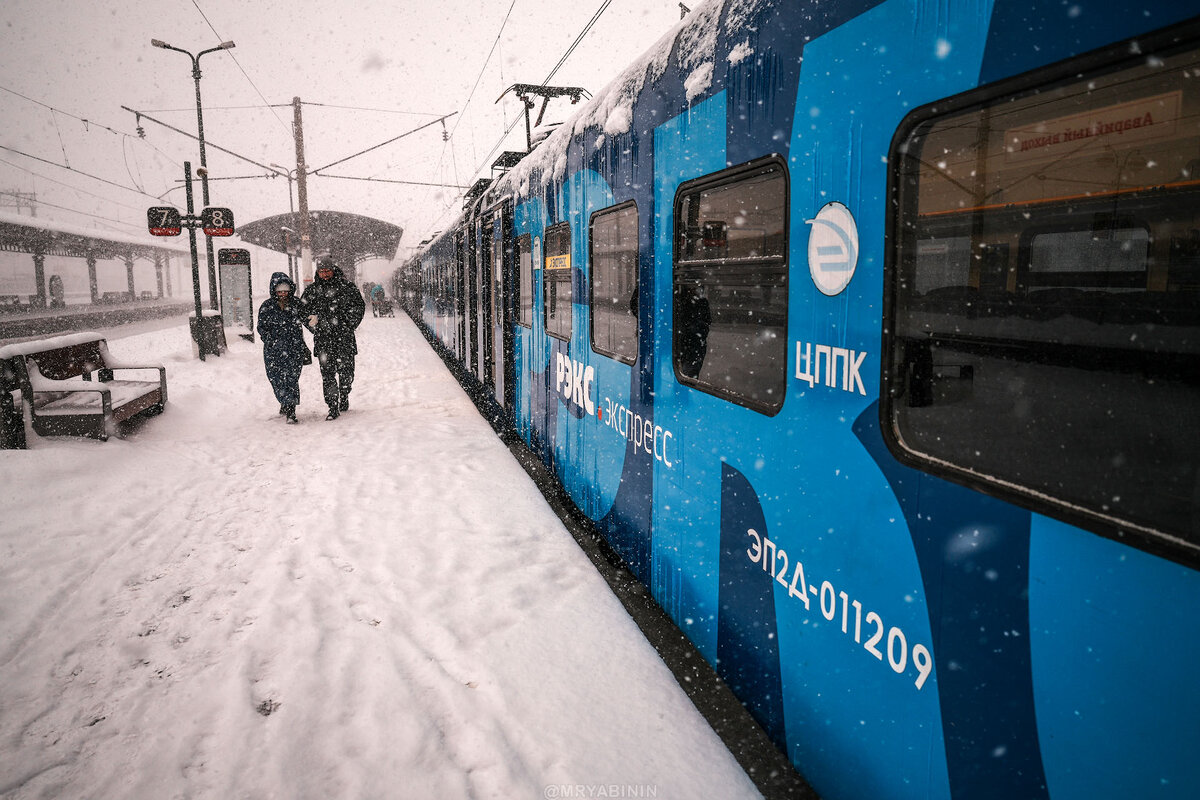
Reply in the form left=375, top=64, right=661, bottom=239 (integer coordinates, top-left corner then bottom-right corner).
left=0, top=333, right=167, bottom=441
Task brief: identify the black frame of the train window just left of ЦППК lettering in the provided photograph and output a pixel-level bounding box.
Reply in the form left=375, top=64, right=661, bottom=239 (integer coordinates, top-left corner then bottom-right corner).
left=670, top=154, right=792, bottom=416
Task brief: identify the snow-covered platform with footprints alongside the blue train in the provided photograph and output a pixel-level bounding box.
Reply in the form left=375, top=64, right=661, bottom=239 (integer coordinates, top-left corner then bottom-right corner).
left=0, top=315, right=758, bottom=800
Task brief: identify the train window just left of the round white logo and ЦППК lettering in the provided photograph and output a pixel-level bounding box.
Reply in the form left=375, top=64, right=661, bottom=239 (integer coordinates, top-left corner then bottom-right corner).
left=672, top=157, right=787, bottom=414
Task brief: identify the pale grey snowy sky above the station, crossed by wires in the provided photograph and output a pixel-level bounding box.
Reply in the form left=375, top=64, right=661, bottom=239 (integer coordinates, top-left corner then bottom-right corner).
left=0, top=0, right=679, bottom=281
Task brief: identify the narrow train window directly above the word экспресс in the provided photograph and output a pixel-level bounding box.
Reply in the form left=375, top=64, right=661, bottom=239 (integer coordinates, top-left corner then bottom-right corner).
left=590, top=201, right=637, bottom=363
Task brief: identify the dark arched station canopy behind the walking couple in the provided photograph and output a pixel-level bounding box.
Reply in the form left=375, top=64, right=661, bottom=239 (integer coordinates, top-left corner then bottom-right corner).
left=238, top=211, right=404, bottom=283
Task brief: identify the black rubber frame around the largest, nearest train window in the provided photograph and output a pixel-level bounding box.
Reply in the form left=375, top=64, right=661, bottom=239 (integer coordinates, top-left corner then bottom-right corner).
left=878, top=22, right=1200, bottom=569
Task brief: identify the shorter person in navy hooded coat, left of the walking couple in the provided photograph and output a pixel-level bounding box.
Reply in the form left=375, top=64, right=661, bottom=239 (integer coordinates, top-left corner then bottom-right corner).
left=258, top=272, right=312, bottom=425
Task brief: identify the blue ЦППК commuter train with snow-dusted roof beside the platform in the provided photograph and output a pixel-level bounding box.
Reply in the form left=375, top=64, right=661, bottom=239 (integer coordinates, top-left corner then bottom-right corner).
left=394, top=0, right=1200, bottom=800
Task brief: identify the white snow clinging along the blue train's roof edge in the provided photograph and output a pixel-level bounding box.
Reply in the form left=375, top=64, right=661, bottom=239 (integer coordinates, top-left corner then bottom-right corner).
left=497, top=0, right=753, bottom=194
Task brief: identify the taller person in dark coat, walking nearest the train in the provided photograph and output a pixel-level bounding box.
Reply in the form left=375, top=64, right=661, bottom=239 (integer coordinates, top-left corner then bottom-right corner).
left=302, top=255, right=367, bottom=420
